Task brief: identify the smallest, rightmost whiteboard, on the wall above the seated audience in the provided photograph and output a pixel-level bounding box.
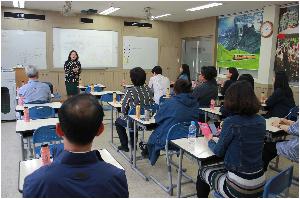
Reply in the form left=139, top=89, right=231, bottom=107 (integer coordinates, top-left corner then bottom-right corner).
left=123, top=36, right=158, bottom=69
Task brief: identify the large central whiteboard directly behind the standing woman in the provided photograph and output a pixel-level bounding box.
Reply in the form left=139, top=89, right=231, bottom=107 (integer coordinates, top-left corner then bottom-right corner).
left=53, top=28, right=118, bottom=69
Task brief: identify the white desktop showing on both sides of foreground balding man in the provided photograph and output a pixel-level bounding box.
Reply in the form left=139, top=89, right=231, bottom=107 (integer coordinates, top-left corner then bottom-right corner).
left=18, top=149, right=124, bottom=193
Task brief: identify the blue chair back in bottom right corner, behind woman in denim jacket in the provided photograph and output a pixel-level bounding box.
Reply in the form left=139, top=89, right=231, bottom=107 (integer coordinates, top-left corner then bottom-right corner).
left=263, top=166, right=293, bottom=198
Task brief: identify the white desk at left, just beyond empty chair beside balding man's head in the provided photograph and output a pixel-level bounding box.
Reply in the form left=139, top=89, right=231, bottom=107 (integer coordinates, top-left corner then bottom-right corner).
left=16, top=118, right=59, bottom=160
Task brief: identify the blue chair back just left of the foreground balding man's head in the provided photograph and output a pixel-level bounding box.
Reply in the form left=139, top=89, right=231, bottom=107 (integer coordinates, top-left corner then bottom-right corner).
left=32, top=125, right=63, bottom=158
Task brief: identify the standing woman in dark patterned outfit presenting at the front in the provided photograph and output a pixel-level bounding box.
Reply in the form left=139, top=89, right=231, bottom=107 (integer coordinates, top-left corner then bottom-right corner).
left=64, top=50, right=81, bottom=97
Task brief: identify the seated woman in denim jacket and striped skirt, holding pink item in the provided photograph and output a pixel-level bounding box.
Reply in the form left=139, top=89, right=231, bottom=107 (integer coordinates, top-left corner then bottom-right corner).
left=196, top=81, right=266, bottom=198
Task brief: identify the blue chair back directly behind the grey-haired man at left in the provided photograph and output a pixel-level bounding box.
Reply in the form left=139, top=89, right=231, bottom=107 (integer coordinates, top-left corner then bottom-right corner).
left=29, top=106, right=55, bottom=120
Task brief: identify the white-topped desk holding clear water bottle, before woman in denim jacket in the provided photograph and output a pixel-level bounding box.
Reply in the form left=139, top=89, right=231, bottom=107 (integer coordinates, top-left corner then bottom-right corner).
left=171, top=137, right=219, bottom=198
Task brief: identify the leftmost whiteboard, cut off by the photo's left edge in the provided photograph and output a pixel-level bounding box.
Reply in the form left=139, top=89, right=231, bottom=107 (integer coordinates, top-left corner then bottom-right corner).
left=1, top=30, right=47, bottom=69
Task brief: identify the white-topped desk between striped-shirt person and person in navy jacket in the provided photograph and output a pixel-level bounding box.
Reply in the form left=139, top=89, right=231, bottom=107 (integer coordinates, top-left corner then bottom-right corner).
left=127, top=115, right=155, bottom=181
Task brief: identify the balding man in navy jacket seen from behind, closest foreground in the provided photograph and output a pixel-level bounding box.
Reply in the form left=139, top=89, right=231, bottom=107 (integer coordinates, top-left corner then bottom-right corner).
left=23, top=94, right=129, bottom=198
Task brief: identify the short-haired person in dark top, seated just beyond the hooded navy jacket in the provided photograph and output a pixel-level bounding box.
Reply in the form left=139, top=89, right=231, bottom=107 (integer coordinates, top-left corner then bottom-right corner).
left=193, top=66, right=218, bottom=107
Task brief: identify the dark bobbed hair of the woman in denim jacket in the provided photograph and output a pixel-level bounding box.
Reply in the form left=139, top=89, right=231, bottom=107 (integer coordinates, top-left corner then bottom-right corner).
left=224, top=81, right=260, bottom=116
